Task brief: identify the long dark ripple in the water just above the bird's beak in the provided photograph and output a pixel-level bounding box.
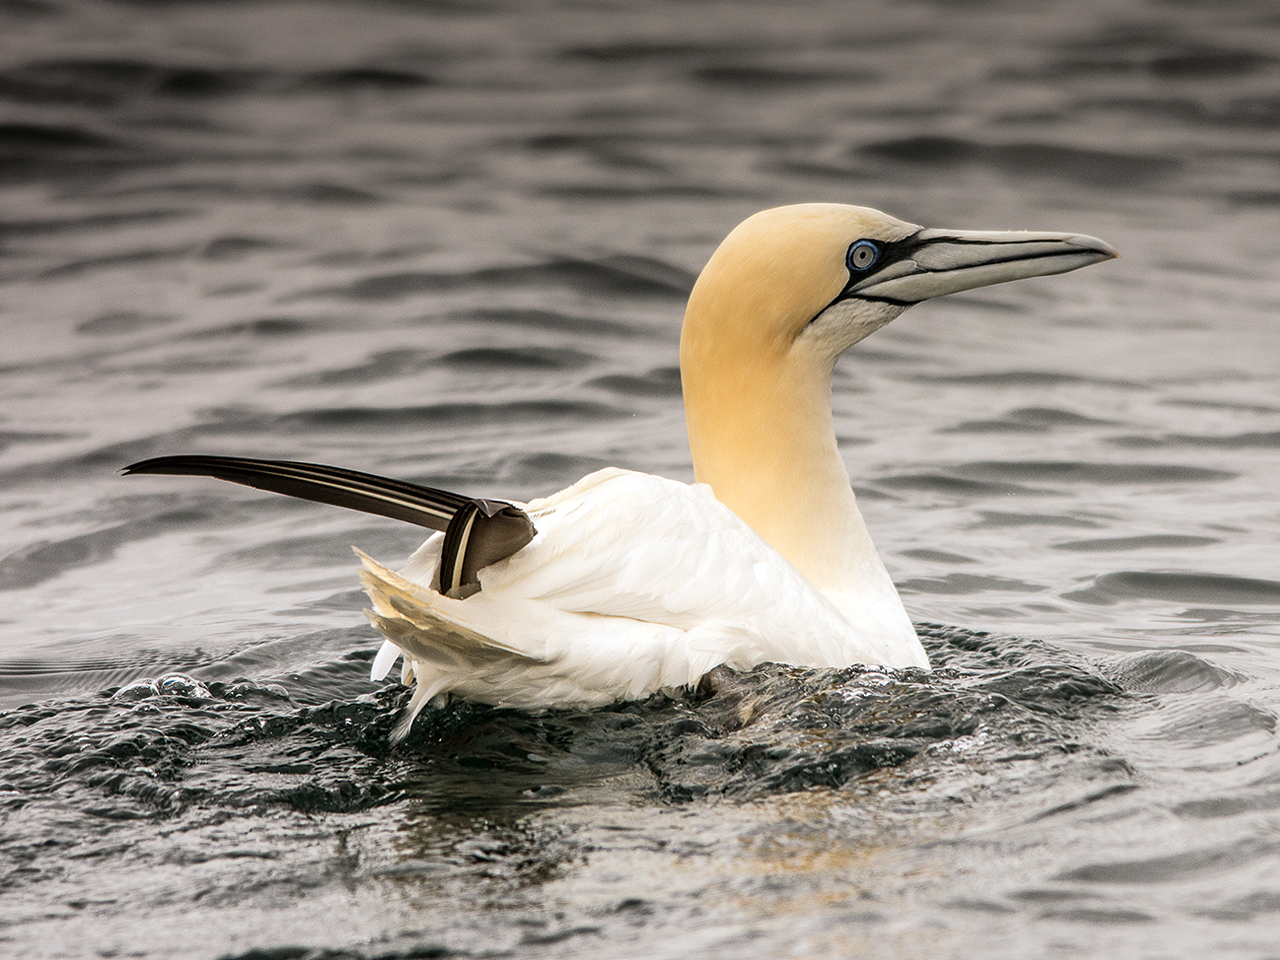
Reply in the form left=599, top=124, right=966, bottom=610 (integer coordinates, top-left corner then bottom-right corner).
left=859, top=134, right=1181, bottom=187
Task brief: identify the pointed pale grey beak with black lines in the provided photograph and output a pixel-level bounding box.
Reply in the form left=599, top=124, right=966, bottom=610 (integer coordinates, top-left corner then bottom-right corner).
left=846, top=230, right=1120, bottom=303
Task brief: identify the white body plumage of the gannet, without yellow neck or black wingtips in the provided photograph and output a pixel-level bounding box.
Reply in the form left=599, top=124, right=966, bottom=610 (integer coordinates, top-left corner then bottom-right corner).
left=360, top=467, right=928, bottom=735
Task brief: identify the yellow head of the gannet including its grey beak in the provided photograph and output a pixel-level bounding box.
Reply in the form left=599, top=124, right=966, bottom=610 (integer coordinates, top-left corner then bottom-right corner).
left=681, top=204, right=1119, bottom=364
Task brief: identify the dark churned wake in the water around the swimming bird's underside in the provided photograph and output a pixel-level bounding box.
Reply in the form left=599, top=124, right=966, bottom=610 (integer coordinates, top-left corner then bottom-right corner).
left=0, top=625, right=1136, bottom=817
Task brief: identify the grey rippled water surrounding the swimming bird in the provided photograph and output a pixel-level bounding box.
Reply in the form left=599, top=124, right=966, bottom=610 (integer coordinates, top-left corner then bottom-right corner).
left=0, top=0, right=1280, bottom=960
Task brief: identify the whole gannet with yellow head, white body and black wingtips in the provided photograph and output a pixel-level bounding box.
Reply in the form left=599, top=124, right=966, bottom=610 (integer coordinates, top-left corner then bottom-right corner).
left=124, top=204, right=1119, bottom=739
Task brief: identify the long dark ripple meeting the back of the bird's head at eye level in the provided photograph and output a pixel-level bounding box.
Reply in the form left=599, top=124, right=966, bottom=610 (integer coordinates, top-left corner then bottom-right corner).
left=309, top=256, right=695, bottom=302
